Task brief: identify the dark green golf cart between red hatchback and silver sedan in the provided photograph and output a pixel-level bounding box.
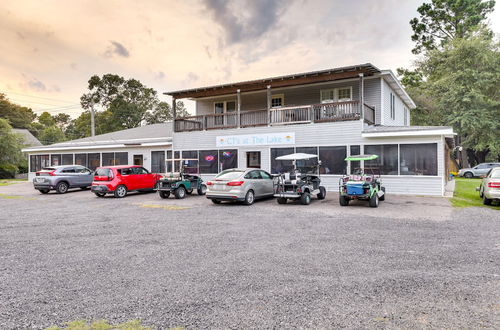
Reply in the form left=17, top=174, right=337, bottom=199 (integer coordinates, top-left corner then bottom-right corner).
left=156, top=159, right=207, bottom=199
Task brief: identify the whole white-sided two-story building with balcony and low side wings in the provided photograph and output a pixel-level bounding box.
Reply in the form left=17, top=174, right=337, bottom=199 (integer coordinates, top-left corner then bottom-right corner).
left=25, top=64, right=454, bottom=196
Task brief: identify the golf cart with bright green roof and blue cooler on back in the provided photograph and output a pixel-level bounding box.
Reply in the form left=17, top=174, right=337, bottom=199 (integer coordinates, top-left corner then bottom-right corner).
left=339, top=155, right=385, bottom=207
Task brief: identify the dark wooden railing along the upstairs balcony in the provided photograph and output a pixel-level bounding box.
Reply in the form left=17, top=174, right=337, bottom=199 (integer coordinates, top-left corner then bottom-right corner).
left=175, top=101, right=375, bottom=132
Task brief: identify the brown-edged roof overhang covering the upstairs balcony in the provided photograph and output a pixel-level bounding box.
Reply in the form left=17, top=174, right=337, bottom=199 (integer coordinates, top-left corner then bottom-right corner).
left=164, top=63, right=380, bottom=99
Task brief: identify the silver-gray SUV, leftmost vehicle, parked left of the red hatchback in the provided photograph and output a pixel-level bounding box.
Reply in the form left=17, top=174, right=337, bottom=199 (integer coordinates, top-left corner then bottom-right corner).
left=33, top=165, right=94, bottom=194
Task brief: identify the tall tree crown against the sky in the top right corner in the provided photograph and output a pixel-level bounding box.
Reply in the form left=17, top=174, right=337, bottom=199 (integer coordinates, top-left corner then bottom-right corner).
left=410, top=0, right=495, bottom=54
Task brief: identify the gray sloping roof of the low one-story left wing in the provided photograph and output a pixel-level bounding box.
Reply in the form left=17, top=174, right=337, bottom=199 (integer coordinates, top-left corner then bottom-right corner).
left=23, top=122, right=172, bottom=151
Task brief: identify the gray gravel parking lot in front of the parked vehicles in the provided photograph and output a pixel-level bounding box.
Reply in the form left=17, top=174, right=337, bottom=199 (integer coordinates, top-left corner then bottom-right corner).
left=0, top=183, right=500, bottom=329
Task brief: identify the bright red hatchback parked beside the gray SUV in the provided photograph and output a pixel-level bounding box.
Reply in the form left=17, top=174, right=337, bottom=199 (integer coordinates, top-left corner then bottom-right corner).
left=91, top=165, right=161, bottom=198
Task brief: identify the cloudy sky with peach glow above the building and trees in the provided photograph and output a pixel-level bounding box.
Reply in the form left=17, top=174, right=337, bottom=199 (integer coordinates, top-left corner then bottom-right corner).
left=0, top=0, right=500, bottom=117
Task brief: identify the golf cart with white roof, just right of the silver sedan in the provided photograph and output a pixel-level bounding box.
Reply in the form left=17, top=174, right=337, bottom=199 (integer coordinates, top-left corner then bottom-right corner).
left=274, top=153, right=326, bottom=205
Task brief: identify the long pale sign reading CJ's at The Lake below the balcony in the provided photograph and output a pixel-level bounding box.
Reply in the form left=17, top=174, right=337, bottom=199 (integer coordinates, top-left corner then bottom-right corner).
left=216, top=132, right=295, bottom=148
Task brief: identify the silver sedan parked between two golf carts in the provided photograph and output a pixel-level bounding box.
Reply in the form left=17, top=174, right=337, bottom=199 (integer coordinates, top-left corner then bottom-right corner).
left=207, top=169, right=274, bottom=205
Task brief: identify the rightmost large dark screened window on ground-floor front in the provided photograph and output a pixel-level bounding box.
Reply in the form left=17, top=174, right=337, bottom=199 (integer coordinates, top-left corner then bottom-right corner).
left=399, top=143, right=437, bottom=175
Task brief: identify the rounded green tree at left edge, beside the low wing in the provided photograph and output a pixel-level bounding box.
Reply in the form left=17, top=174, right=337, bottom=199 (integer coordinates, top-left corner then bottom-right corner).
left=0, top=118, right=26, bottom=178
